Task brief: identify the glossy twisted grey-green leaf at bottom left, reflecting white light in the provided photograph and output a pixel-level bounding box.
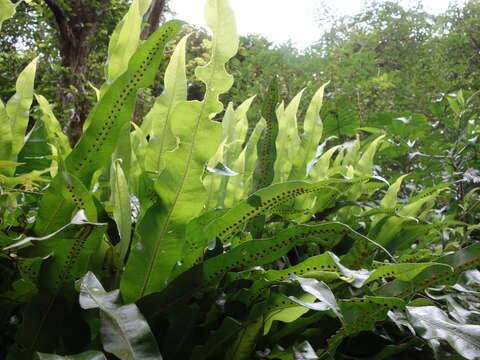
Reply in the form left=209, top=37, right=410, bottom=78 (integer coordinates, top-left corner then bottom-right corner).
left=80, top=272, right=162, bottom=360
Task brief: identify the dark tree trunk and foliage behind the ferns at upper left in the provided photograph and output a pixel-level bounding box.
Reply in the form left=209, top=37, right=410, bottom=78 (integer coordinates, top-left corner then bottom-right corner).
left=0, top=0, right=171, bottom=144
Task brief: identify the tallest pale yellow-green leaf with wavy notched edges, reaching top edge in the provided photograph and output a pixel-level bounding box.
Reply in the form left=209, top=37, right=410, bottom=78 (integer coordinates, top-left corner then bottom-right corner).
left=121, top=0, right=238, bottom=301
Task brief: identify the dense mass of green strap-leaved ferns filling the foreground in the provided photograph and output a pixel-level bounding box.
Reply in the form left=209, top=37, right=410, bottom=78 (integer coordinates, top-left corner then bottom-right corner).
left=0, top=0, right=480, bottom=360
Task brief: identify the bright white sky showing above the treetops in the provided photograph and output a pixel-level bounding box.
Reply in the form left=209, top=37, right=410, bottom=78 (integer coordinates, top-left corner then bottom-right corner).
left=170, top=0, right=464, bottom=48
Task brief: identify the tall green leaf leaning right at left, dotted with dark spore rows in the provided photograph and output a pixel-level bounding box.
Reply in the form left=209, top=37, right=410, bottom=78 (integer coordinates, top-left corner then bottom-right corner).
left=35, top=21, right=180, bottom=235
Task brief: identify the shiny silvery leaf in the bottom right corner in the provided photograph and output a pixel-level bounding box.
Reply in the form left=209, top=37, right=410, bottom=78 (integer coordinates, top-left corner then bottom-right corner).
left=407, top=306, right=480, bottom=360
